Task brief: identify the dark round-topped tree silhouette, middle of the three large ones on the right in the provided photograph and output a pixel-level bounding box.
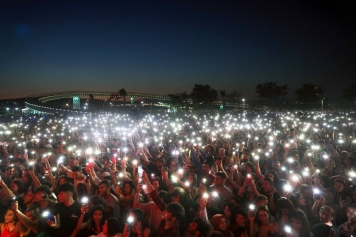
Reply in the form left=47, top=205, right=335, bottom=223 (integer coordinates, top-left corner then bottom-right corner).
left=256, top=81, right=288, bottom=101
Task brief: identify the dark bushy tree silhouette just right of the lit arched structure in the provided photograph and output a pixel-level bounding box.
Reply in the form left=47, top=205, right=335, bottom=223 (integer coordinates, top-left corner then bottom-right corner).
left=190, top=84, right=218, bottom=108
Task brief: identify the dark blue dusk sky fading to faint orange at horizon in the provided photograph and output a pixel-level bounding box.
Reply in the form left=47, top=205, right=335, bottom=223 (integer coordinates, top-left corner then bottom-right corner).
left=0, top=0, right=356, bottom=100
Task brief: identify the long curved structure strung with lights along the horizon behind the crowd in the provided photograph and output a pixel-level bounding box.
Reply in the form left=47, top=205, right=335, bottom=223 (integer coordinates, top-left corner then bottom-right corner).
left=24, top=91, right=250, bottom=114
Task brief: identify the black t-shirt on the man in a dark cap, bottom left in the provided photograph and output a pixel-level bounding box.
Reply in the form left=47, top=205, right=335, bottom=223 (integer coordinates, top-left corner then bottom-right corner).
left=53, top=201, right=82, bottom=237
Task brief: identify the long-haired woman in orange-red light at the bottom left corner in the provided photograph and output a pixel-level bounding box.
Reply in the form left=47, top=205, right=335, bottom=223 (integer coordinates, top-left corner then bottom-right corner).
left=0, top=209, right=22, bottom=237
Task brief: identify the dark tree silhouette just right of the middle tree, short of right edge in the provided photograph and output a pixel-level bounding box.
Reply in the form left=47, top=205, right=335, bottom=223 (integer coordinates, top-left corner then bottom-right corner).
left=295, top=84, right=326, bottom=104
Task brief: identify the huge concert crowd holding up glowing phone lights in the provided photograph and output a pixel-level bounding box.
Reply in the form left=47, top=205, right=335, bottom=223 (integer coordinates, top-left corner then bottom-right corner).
left=0, top=111, right=356, bottom=237
